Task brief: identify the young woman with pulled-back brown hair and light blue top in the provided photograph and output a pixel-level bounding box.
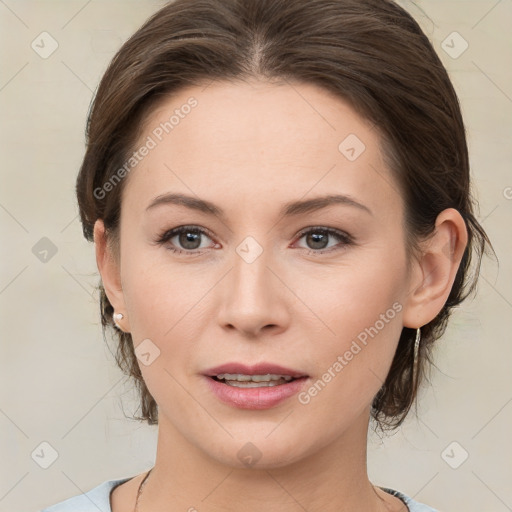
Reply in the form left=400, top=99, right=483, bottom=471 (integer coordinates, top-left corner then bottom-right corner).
left=39, top=0, right=490, bottom=512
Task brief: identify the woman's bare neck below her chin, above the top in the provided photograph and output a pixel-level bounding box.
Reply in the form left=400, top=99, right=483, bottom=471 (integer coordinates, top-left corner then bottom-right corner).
left=140, top=411, right=385, bottom=512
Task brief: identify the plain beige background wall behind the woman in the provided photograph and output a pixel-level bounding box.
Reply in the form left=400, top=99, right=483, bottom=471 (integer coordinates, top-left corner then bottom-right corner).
left=0, top=0, right=512, bottom=512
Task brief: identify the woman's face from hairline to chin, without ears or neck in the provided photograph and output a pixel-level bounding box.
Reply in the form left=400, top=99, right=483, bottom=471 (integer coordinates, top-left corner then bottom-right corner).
left=103, top=82, right=416, bottom=467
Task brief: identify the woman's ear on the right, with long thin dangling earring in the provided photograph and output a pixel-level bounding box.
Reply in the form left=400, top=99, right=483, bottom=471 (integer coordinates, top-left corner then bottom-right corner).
left=403, top=208, right=468, bottom=329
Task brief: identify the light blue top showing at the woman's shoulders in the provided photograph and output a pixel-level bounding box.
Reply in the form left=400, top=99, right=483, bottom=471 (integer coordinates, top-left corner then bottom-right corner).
left=40, top=477, right=438, bottom=512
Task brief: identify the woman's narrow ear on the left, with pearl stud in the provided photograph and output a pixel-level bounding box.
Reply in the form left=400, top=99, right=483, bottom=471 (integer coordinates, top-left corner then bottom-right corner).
left=94, top=219, right=130, bottom=332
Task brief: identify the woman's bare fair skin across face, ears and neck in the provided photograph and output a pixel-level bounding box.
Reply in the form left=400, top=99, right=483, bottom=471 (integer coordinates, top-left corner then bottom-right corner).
left=94, top=81, right=467, bottom=512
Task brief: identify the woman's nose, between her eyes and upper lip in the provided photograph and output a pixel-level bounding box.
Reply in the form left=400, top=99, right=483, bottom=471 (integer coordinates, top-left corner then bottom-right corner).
left=218, top=246, right=294, bottom=339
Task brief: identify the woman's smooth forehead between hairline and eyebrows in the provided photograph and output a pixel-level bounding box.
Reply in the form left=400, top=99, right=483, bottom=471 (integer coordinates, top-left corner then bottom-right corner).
left=126, top=82, right=396, bottom=218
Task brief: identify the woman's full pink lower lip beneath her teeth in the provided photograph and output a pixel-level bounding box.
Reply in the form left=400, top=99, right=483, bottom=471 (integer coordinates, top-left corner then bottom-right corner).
left=205, top=376, right=307, bottom=409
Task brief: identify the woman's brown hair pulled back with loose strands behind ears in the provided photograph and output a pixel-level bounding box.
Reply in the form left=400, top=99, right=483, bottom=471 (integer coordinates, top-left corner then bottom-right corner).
left=76, top=0, right=492, bottom=428
